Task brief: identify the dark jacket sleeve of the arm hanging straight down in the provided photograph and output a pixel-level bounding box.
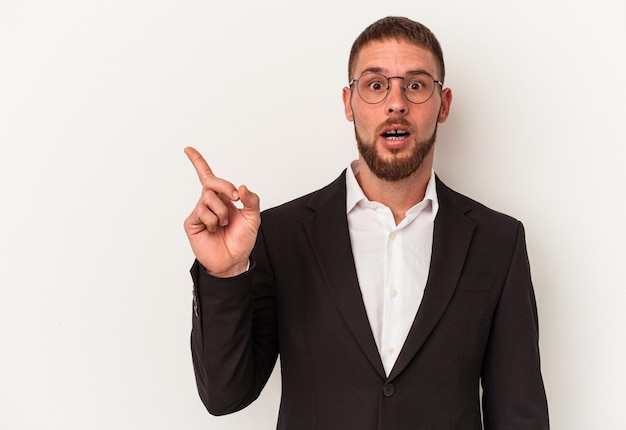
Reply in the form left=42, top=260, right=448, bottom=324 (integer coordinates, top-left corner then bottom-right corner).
left=482, top=224, right=549, bottom=430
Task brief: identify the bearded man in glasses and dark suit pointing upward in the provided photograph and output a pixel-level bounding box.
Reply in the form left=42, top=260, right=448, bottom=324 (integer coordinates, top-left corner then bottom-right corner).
left=185, top=17, right=548, bottom=430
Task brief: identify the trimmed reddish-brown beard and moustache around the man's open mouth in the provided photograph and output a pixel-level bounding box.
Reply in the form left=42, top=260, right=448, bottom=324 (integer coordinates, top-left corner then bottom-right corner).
left=354, top=120, right=437, bottom=181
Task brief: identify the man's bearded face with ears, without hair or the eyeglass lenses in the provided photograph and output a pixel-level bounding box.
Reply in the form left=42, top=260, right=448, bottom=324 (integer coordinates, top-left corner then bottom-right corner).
left=343, top=40, right=452, bottom=181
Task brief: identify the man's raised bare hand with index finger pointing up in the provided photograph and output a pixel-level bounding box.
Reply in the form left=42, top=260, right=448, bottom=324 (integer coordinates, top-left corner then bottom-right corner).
left=184, top=147, right=261, bottom=277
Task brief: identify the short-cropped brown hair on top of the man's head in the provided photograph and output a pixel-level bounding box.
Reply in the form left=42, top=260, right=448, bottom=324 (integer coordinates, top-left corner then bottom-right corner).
left=348, top=16, right=446, bottom=82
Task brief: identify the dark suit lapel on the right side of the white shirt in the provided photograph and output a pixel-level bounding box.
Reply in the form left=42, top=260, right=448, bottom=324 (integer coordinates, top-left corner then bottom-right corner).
left=389, top=179, right=474, bottom=380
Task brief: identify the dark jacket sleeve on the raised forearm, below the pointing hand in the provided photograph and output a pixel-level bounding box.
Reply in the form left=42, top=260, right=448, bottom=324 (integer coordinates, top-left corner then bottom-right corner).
left=191, top=227, right=278, bottom=415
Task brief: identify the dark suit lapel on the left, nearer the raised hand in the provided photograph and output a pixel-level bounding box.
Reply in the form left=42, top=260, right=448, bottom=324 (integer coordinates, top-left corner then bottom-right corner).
left=303, top=174, right=385, bottom=378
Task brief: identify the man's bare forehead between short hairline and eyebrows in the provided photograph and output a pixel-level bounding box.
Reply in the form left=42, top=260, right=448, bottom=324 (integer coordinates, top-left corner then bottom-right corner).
left=354, top=39, right=438, bottom=77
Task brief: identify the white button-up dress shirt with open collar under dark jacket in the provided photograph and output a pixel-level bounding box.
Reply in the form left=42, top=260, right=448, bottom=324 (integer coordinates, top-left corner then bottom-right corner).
left=346, top=161, right=439, bottom=376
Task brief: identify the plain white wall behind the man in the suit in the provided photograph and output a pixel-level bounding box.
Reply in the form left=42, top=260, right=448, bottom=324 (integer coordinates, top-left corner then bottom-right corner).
left=0, top=0, right=626, bottom=430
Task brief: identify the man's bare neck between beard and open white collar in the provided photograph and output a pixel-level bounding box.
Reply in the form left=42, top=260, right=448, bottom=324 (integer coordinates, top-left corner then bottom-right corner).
left=357, top=151, right=433, bottom=224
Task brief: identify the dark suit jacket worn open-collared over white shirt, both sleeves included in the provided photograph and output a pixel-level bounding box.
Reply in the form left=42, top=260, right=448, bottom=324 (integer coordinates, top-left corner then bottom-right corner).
left=192, top=174, right=548, bottom=430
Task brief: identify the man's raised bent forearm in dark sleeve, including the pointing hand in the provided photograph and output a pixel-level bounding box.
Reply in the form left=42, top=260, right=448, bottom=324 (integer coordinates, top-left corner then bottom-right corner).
left=184, top=148, right=278, bottom=415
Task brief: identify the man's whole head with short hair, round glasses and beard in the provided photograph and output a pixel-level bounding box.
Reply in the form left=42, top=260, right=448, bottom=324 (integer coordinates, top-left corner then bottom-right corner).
left=343, top=17, right=452, bottom=181
